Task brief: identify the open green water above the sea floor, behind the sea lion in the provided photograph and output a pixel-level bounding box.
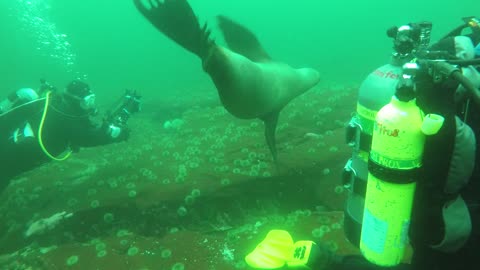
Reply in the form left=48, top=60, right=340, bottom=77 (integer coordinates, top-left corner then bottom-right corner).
left=0, top=0, right=478, bottom=99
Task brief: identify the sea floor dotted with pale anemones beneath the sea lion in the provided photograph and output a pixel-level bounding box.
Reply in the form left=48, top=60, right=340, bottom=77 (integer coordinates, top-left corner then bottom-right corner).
left=0, top=83, right=386, bottom=270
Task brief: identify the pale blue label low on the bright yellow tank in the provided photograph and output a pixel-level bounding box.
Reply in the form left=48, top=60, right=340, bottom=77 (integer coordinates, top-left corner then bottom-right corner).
left=362, top=209, right=388, bottom=254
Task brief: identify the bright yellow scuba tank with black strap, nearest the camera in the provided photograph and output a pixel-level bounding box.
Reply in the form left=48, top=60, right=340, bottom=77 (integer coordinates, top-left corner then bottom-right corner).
left=360, top=70, right=443, bottom=266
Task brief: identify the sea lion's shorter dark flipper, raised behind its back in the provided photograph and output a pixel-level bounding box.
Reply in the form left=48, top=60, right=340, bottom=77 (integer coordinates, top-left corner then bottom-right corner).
left=217, top=15, right=270, bottom=62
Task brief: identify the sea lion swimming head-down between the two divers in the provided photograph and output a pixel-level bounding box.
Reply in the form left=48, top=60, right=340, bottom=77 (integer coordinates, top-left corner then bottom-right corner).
left=134, top=0, right=320, bottom=162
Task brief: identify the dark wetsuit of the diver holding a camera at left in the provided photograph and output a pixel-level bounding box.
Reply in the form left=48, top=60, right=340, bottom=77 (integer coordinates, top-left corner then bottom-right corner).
left=0, top=95, right=128, bottom=192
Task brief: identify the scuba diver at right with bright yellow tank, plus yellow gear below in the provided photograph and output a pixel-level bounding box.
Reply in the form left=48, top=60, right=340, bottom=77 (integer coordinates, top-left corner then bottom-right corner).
left=245, top=17, right=480, bottom=270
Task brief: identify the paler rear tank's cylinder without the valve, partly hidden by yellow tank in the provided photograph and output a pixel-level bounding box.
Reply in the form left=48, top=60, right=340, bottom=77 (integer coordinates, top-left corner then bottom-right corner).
left=343, top=59, right=405, bottom=247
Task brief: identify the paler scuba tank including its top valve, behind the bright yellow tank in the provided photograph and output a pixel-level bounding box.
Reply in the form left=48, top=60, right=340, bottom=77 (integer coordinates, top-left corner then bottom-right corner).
left=343, top=22, right=431, bottom=247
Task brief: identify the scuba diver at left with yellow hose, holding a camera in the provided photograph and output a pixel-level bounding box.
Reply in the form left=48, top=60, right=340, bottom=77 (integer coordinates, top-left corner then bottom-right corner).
left=0, top=80, right=140, bottom=192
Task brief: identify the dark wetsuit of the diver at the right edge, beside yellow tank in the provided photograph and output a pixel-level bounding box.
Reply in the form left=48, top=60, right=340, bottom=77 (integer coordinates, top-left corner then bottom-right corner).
left=410, top=64, right=480, bottom=269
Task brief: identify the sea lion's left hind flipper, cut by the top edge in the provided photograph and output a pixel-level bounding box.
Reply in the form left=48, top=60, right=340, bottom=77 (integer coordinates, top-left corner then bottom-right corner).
left=133, top=0, right=215, bottom=59
